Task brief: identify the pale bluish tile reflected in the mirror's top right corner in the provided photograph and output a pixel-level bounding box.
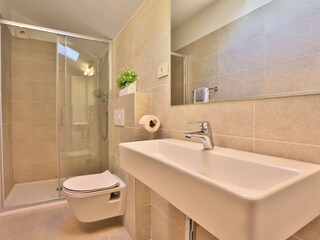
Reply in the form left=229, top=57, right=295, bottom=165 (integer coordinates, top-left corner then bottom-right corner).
left=265, top=0, right=320, bottom=33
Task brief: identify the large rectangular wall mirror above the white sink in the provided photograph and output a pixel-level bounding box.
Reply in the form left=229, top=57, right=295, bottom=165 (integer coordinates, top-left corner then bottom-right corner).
left=171, top=0, right=320, bottom=105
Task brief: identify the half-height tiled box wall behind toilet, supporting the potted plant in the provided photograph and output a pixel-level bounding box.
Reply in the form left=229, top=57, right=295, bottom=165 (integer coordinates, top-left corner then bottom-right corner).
left=109, top=93, right=151, bottom=240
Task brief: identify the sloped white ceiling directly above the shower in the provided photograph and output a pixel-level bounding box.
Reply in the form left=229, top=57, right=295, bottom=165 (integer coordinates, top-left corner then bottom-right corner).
left=11, top=0, right=144, bottom=38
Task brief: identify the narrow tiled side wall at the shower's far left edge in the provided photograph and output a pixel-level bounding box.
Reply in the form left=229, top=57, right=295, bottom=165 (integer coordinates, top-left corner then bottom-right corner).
left=1, top=25, right=14, bottom=197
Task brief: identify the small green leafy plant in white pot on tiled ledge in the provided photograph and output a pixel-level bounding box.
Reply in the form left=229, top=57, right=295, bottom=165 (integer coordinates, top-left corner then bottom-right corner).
left=116, top=69, right=138, bottom=96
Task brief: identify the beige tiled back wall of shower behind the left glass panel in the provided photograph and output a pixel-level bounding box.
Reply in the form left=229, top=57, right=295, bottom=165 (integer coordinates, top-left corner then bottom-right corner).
left=12, top=37, right=57, bottom=183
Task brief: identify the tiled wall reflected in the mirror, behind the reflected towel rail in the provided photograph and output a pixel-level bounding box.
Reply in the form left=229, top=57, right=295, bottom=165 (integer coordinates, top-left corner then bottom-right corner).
left=172, top=1, right=320, bottom=103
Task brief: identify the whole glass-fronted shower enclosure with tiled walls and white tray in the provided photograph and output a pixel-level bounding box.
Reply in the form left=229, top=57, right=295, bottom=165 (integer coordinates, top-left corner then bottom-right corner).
left=0, top=20, right=109, bottom=208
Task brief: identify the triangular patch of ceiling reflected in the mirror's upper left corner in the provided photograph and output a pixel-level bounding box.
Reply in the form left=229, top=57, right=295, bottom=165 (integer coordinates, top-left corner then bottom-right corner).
left=171, top=0, right=216, bottom=29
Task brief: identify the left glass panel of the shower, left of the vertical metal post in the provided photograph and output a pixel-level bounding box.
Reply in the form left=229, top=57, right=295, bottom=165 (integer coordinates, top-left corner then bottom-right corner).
left=1, top=25, right=59, bottom=207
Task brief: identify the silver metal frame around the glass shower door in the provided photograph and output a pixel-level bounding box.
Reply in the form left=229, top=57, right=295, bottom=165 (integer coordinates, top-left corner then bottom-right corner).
left=0, top=19, right=113, bottom=210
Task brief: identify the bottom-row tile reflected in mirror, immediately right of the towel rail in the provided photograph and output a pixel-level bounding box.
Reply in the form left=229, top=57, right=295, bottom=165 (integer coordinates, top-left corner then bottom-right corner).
left=218, top=67, right=265, bottom=100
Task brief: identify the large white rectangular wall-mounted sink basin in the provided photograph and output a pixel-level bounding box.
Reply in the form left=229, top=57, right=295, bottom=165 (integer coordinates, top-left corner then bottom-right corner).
left=119, top=139, right=320, bottom=240
